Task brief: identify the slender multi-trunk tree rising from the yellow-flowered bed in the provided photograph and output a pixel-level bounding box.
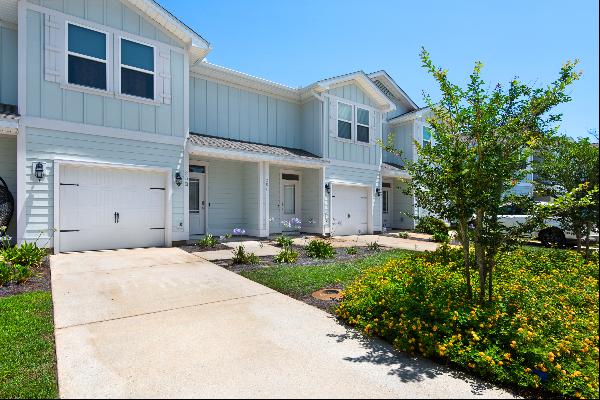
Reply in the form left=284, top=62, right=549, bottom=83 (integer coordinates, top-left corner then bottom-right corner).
left=386, top=49, right=579, bottom=301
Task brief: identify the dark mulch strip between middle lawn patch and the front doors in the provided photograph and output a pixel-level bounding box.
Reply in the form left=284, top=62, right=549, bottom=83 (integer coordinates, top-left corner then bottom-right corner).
left=212, top=245, right=389, bottom=273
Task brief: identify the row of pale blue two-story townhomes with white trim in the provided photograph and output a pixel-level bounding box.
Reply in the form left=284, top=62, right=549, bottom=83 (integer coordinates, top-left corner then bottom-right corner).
left=0, top=0, right=429, bottom=252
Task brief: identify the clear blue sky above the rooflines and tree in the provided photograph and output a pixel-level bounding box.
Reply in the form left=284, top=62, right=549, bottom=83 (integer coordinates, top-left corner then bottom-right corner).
left=159, top=0, right=599, bottom=136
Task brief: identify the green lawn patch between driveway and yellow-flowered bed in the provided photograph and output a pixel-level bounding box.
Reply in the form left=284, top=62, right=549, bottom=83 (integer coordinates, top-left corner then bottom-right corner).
left=241, top=250, right=413, bottom=297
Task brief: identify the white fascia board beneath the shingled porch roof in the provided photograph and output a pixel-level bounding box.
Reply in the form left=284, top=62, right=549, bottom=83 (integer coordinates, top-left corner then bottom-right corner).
left=188, top=144, right=327, bottom=168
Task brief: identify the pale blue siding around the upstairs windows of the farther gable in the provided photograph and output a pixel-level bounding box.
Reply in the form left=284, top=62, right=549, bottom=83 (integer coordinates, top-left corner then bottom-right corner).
left=323, top=84, right=381, bottom=165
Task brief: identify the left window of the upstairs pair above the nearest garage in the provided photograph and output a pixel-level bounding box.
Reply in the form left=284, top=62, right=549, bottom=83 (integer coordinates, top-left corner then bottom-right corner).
left=67, top=23, right=108, bottom=90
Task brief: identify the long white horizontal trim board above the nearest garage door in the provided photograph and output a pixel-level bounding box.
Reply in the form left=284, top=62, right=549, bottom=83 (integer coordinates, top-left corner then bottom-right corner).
left=21, top=117, right=185, bottom=146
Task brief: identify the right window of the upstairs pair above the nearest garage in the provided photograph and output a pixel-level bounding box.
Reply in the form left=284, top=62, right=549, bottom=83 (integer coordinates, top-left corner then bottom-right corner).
left=121, top=38, right=154, bottom=100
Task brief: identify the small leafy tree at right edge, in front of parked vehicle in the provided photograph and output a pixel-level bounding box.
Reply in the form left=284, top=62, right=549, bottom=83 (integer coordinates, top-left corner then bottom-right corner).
left=533, top=136, right=599, bottom=255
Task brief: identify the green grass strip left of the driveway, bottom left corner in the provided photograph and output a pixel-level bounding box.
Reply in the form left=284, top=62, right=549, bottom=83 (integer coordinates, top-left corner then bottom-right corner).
left=0, top=292, right=57, bottom=398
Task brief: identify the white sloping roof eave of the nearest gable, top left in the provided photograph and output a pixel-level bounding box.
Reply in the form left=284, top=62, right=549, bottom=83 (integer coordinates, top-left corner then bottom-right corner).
left=124, top=0, right=212, bottom=64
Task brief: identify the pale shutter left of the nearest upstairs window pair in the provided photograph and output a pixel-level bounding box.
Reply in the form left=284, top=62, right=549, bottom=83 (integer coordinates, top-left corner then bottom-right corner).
left=44, top=14, right=66, bottom=83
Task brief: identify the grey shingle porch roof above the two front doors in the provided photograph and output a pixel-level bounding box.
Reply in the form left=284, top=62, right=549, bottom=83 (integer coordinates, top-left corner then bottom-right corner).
left=190, top=133, right=320, bottom=160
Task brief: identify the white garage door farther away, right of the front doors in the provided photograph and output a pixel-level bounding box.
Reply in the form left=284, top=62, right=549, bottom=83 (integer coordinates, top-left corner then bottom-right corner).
left=331, top=185, right=369, bottom=235
